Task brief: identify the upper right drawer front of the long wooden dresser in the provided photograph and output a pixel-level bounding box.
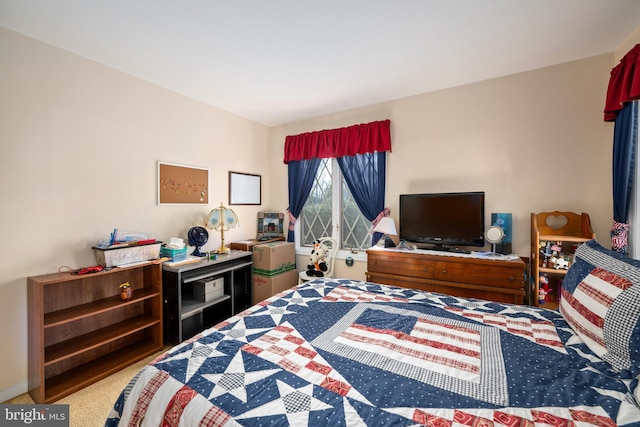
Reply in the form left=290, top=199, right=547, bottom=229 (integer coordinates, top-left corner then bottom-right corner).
left=435, top=261, right=524, bottom=289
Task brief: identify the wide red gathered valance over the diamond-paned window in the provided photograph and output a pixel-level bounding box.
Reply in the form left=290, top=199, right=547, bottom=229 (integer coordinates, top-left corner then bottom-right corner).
left=284, top=120, right=391, bottom=163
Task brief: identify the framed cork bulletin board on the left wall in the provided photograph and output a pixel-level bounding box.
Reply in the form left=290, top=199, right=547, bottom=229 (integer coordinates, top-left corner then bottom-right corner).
left=158, top=162, right=209, bottom=205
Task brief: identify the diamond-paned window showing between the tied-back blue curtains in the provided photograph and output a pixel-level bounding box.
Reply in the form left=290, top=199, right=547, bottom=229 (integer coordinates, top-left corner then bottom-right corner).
left=296, top=159, right=372, bottom=260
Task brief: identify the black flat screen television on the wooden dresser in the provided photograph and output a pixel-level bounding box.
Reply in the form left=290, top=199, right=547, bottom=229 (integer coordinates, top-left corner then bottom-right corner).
left=399, top=191, right=484, bottom=250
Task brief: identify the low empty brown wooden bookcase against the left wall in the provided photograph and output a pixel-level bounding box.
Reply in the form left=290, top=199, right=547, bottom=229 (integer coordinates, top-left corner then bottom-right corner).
left=27, top=263, right=163, bottom=403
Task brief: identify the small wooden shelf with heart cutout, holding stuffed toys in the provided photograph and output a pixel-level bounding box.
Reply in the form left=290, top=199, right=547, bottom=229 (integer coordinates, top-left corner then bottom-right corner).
left=530, top=211, right=596, bottom=310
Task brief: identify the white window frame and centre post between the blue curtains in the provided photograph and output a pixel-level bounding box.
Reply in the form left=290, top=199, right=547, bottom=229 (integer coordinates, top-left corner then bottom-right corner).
left=294, top=158, right=367, bottom=262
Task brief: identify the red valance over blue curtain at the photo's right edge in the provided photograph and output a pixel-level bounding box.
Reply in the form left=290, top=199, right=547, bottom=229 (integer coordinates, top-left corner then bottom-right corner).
left=604, top=44, right=640, bottom=122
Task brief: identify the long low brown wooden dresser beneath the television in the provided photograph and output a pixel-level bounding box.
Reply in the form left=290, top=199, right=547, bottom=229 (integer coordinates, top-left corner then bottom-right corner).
left=366, top=248, right=525, bottom=304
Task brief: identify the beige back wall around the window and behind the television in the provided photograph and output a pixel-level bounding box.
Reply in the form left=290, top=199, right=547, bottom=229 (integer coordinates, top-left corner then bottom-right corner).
left=270, top=54, right=613, bottom=279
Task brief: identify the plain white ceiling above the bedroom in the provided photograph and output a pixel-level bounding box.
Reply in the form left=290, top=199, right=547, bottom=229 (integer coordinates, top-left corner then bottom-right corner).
left=0, top=0, right=640, bottom=126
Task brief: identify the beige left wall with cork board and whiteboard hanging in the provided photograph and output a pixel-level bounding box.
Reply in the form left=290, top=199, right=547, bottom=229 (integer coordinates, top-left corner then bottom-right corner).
left=0, top=28, right=271, bottom=401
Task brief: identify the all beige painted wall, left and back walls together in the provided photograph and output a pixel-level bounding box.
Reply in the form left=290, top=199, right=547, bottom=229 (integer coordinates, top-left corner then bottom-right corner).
left=0, top=23, right=633, bottom=401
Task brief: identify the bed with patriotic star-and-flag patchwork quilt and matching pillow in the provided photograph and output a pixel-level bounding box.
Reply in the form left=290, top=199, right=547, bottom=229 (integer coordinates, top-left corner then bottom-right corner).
left=106, top=241, right=640, bottom=426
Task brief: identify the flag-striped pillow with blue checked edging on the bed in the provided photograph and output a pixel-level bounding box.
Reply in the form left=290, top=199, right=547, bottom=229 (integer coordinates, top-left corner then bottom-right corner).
left=560, top=240, right=640, bottom=378
